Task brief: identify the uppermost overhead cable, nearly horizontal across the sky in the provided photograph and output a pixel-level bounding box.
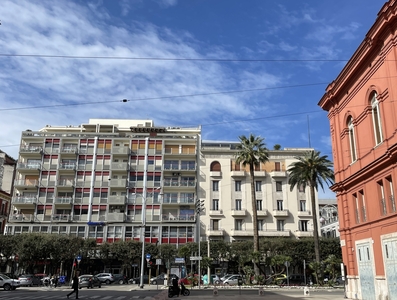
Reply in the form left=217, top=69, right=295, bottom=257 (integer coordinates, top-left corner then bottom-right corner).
left=0, top=53, right=349, bottom=62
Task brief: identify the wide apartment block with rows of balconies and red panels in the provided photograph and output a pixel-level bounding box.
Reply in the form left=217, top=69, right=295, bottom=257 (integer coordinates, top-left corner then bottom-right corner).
left=5, top=119, right=201, bottom=244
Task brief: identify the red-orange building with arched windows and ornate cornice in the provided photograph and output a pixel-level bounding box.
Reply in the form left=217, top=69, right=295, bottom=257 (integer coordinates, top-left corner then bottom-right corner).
left=319, top=0, right=397, bottom=299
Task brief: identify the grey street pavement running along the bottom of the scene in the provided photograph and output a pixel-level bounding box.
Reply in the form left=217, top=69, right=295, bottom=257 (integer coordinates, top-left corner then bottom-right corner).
left=0, top=285, right=344, bottom=300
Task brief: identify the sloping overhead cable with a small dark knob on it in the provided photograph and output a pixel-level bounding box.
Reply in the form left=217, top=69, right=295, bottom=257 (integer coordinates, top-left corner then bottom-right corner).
left=0, top=82, right=328, bottom=111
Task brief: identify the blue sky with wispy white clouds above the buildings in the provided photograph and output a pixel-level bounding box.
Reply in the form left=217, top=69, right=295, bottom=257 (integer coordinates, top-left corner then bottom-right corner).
left=0, top=0, right=385, bottom=198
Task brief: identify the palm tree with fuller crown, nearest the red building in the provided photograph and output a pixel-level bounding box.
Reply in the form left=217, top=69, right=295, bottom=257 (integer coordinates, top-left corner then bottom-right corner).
left=288, top=150, right=335, bottom=263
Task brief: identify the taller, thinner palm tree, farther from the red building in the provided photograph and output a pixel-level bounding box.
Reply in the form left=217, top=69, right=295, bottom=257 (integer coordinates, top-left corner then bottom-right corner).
left=236, top=134, right=269, bottom=275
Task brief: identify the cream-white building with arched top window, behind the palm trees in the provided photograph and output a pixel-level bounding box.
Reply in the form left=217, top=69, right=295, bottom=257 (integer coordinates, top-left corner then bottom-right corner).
left=199, top=141, right=318, bottom=242
